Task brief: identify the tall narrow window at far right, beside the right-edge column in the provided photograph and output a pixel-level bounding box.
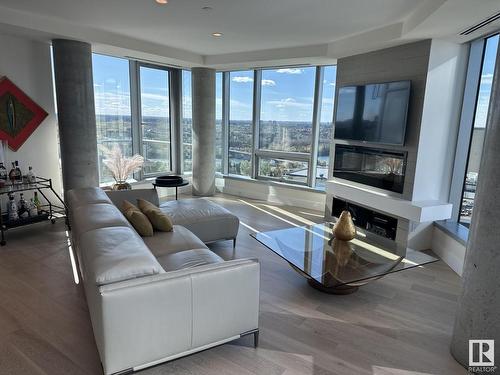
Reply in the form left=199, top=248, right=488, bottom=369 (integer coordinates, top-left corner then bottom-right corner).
left=459, top=34, right=499, bottom=225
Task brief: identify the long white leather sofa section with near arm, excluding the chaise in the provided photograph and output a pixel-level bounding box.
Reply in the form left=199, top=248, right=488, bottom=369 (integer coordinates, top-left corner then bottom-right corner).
left=66, top=188, right=260, bottom=374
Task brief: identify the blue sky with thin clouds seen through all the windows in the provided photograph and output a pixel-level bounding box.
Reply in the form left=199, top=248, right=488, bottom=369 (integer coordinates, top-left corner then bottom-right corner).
left=93, top=35, right=499, bottom=127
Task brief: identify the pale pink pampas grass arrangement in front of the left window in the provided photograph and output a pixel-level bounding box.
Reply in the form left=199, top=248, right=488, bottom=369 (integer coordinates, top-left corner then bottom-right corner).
left=99, top=145, right=144, bottom=184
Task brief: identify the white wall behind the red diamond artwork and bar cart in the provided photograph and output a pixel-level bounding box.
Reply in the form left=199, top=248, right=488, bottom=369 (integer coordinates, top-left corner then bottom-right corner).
left=0, top=34, right=62, bottom=192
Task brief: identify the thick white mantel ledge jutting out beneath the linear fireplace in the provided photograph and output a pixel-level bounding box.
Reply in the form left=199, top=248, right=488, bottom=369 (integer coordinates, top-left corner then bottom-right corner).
left=326, top=179, right=452, bottom=223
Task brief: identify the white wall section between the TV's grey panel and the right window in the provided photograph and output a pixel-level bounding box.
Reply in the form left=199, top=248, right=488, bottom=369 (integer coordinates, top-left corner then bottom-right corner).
left=412, top=39, right=468, bottom=202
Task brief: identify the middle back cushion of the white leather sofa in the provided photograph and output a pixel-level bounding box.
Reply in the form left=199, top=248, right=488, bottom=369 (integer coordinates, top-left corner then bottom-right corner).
left=71, top=203, right=130, bottom=239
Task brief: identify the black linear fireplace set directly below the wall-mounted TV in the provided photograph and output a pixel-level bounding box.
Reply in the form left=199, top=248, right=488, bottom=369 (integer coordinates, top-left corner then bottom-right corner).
left=333, top=144, right=407, bottom=193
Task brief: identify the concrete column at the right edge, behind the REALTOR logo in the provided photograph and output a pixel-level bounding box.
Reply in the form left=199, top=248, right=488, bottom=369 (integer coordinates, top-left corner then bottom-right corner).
left=451, top=43, right=500, bottom=373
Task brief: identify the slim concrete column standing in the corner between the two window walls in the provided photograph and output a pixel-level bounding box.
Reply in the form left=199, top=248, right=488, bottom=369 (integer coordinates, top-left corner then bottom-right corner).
left=191, top=68, right=215, bottom=196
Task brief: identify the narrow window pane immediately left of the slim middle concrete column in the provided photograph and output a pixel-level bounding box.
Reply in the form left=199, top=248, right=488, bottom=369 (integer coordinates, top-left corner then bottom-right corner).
left=181, top=70, right=193, bottom=173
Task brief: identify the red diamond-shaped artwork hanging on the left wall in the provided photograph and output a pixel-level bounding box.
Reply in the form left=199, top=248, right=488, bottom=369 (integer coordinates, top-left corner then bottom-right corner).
left=0, top=77, right=48, bottom=151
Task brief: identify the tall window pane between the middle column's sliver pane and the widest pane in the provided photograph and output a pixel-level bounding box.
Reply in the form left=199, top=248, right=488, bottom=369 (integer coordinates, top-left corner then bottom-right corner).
left=228, top=70, right=254, bottom=176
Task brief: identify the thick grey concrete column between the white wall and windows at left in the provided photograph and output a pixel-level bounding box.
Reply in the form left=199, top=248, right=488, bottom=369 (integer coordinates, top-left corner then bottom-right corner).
left=52, top=39, right=99, bottom=191
